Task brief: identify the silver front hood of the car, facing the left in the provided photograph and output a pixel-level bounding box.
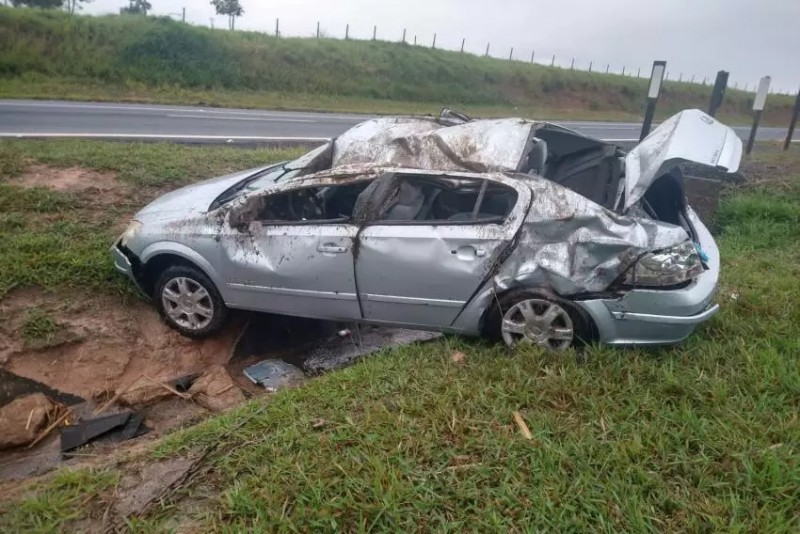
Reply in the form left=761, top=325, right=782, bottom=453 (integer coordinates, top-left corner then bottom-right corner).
left=134, top=165, right=272, bottom=222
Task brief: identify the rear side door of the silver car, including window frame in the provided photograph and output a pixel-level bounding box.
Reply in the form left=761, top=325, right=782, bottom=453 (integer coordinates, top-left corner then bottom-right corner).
left=355, top=172, right=531, bottom=328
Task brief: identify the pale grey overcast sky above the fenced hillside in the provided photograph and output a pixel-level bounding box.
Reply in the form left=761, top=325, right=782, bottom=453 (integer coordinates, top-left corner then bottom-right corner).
left=84, top=0, right=800, bottom=93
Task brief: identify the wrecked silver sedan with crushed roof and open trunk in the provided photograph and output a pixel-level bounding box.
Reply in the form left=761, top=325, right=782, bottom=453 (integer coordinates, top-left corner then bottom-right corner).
left=112, top=110, right=741, bottom=350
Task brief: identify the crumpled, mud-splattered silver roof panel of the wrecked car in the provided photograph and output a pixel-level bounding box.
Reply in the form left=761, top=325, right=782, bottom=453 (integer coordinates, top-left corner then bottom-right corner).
left=333, top=117, right=539, bottom=172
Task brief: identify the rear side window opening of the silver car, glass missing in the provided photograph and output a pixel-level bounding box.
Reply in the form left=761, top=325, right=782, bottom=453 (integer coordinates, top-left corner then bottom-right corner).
left=379, top=175, right=517, bottom=224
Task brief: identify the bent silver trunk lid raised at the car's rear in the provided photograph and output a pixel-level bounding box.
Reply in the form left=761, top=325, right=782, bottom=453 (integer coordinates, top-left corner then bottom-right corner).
left=623, top=109, right=742, bottom=209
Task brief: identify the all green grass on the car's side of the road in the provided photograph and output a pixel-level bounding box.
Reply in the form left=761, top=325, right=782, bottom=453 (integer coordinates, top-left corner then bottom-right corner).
left=0, top=141, right=800, bottom=532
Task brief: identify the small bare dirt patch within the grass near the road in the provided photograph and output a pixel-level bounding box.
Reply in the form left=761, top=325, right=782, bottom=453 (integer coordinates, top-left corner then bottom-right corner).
left=10, top=165, right=126, bottom=196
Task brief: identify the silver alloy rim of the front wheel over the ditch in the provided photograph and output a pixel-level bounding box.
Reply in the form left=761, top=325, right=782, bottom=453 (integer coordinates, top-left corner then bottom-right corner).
left=161, top=276, right=214, bottom=330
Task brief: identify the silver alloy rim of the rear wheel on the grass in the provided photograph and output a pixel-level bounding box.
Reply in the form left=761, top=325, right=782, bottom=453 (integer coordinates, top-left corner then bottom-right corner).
left=501, top=299, right=575, bottom=350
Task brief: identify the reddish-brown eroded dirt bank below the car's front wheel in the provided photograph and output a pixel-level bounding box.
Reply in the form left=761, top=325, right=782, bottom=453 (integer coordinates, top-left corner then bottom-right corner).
left=0, top=290, right=241, bottom=399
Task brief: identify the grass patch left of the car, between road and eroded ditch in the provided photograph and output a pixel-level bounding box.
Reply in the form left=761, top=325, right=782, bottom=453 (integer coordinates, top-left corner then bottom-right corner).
left=0, top=140, right=303, bottom=298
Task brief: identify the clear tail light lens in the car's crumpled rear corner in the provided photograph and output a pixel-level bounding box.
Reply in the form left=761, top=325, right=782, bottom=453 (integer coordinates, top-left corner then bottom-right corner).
left=625, top=241, right=705, bottom=286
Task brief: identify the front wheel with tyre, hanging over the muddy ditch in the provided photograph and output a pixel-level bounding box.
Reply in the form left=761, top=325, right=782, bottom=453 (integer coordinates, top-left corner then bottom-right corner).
left=153, top=265, right=228, bottom=339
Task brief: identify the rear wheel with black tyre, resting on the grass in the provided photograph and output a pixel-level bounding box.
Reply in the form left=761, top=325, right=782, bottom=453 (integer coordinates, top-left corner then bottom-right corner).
left=486, top=289, right=593, bottom=351
